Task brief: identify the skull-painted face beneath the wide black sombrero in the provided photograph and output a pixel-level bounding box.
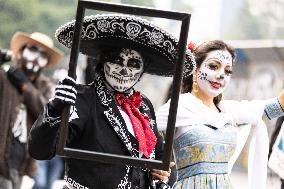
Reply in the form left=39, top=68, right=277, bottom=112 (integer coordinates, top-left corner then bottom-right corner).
left=104, top=49, right=144, bottom=92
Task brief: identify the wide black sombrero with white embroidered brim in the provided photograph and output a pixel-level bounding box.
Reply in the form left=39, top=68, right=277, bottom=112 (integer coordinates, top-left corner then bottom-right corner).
left=55, top=14, right=196, bottom=76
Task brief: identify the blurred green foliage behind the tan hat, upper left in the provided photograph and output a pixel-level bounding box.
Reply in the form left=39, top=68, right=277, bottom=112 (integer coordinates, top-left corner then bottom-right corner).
left=0, top=0, right=77, bottom=50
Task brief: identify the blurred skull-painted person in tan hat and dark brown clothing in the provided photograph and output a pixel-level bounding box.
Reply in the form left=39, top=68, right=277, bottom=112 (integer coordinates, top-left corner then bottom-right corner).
left=0, top=32, right=63, bottom=189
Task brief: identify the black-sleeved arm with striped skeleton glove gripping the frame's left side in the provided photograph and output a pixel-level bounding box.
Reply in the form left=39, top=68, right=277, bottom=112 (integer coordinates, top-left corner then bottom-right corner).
left=28, top=77, right=77, bottom=159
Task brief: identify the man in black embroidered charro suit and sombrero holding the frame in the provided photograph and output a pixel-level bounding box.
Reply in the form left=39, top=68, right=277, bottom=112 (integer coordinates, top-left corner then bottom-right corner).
left=29, top=14, right=193, bottom=189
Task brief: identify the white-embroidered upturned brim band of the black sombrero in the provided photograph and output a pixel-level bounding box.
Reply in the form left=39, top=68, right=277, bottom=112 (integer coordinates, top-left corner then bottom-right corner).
left=55, top=14, right=196, bottom=75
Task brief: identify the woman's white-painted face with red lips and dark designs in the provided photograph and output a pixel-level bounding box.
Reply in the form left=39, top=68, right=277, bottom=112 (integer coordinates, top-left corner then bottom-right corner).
left=197, top=50, right=233, bottom=97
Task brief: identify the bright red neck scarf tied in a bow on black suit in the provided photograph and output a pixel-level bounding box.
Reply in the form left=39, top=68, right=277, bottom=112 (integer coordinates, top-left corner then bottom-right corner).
left=115, top=92, right=157, bottom=158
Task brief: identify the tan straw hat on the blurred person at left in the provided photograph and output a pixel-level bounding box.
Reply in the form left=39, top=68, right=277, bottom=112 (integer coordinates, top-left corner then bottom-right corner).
left=10, top=32, right=64, bottom=67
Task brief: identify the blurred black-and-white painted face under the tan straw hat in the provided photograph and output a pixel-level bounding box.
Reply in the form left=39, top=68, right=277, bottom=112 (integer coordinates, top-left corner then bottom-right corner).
left=22, top=45, right=48, bottom=73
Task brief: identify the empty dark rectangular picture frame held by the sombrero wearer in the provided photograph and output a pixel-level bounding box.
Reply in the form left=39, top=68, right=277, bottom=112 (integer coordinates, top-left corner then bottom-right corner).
left=56, top=0, right=191, bottom=170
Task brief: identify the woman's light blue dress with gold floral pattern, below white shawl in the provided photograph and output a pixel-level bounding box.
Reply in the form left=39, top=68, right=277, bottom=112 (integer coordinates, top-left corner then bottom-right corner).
left=173, top=125, right=237, bottom=189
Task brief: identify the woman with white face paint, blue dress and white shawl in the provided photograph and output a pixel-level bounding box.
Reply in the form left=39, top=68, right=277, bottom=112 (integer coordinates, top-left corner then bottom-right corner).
left=156, top=40, right=284, bottom=189
